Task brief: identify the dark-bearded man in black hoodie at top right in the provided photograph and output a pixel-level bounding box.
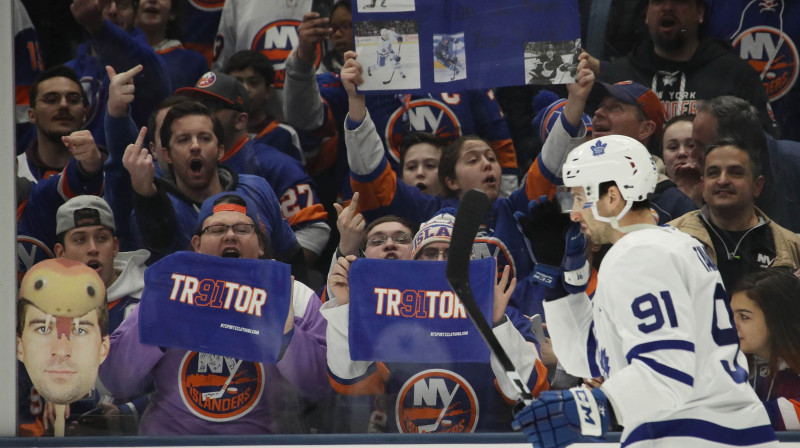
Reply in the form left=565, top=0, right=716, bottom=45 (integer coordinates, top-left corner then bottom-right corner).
left=595, top=0, right=775, bottom=132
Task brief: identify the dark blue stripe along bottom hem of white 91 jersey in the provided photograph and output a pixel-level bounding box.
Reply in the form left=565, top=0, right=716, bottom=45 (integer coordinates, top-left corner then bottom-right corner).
left=622, top=419, right=777, bottom=447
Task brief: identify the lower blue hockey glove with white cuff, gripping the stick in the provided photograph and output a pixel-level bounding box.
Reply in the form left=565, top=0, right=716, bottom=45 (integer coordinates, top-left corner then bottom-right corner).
left=511, top=387, right=610, bottom=448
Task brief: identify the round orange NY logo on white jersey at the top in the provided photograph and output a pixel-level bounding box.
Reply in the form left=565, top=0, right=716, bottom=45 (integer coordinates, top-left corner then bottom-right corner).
left=250, top=20, right=322, bottom=89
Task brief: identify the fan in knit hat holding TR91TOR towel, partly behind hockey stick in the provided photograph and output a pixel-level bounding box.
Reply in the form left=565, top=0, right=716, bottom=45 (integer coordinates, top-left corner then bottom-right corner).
left=322, top=209, right=548, bottom=433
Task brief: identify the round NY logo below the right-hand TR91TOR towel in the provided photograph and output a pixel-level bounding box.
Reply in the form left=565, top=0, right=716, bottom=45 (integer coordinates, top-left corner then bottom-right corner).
left=395, top=369, right=478, bottom=433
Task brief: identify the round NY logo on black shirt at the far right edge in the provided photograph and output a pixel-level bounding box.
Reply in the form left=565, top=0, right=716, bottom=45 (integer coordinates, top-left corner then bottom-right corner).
left=732, top=26, right=798, bottom=101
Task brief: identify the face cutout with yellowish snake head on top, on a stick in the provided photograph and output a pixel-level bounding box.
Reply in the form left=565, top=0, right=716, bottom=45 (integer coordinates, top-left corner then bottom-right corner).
left=17, top=258, right=109, bottom=404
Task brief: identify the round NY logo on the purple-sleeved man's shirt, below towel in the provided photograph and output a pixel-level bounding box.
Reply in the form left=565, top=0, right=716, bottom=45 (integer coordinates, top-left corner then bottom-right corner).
left=178, top=352, right=264, bottom=422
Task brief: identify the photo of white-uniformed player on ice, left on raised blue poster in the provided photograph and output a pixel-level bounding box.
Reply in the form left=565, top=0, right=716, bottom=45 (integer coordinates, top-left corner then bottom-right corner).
left=354, top=19, right=421, bottom=92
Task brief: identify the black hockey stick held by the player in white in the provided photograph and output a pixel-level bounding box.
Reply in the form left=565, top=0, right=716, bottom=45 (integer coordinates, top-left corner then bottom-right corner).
left=447, top=190, right=533, bottom=405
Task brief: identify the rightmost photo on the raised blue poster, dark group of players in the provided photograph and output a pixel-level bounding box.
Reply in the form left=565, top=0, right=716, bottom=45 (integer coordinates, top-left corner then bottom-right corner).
left=523, top=39, right=581, bottom=85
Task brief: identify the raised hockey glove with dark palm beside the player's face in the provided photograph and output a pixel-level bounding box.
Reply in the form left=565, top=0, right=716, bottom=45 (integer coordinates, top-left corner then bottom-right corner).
left=514, top=196, right=590, bottom=298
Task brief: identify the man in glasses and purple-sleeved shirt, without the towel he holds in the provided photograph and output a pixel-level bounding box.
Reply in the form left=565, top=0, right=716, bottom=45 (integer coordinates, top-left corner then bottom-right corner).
left=100, top=192, right=330, bottom=435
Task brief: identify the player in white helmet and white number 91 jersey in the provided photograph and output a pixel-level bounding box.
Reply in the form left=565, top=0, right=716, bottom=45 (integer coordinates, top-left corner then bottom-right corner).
left=514, top=135, right=777, bottom=447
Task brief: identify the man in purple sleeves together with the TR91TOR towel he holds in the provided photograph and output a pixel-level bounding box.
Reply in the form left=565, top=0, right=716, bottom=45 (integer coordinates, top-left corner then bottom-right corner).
left=100, top=192, right=330, bottom=435
